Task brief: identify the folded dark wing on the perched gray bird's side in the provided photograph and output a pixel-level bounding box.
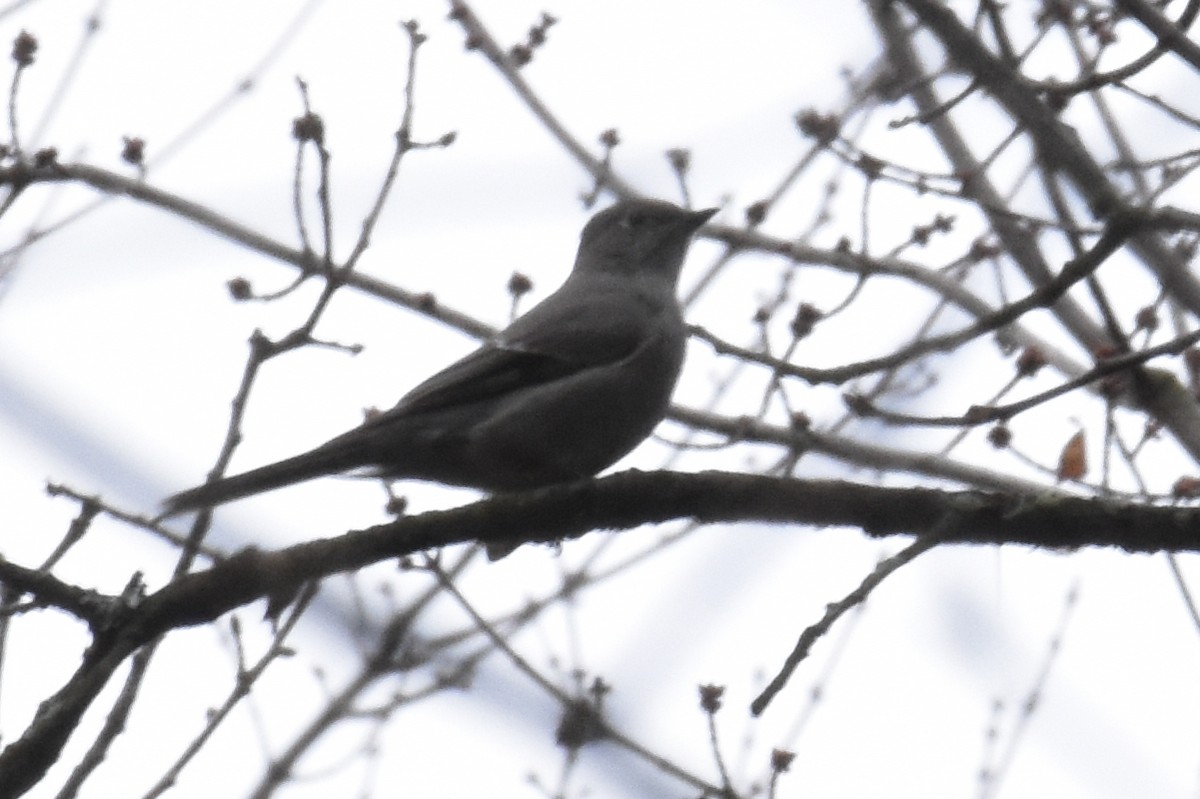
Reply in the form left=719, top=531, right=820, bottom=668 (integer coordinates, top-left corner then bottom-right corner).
left=384, top=279, right=644, bottom=416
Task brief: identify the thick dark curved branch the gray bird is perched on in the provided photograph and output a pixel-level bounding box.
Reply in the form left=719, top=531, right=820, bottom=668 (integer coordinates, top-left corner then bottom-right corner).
left=0, top=471, right=1200, bottom=795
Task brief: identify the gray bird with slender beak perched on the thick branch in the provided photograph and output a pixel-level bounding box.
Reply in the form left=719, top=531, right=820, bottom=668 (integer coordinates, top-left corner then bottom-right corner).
left=163, top=199, right=716, bottom=516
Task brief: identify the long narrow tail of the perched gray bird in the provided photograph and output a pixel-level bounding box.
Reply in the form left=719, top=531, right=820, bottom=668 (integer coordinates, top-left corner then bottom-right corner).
left=160, top=447, right=362, bottom=518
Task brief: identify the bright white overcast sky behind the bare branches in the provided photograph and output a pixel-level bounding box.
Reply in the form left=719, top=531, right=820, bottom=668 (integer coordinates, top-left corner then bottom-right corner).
left=0, top=0, right=1200, bottom=798
